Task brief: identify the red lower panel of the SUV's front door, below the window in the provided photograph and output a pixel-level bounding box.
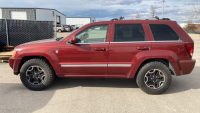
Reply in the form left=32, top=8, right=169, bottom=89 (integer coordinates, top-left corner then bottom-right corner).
left=60, top=43, right=109, bottom=75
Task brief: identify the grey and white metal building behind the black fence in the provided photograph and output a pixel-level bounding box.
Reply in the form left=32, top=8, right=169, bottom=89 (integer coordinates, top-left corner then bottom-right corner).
left=0, top=7, right=66, bottom=24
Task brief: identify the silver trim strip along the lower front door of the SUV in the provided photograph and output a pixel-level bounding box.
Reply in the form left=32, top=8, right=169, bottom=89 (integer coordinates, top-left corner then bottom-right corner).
left=61, top=64, right=107, bottom=67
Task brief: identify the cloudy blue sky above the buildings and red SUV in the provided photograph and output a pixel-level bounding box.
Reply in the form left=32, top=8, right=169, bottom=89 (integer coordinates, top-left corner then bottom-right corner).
left=0, top=0, right=200, bottom=23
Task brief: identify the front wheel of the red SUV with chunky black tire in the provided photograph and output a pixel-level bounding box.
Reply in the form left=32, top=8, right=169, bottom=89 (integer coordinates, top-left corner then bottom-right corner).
left=20, top=58, right=55, bottom=91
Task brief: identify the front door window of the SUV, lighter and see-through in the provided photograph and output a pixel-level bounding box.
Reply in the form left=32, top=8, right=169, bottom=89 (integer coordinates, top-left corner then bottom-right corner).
left=76, top=25, right=109, bottom=43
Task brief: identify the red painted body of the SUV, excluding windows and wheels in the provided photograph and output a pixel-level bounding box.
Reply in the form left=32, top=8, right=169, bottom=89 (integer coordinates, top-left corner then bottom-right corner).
left=9, top=20, right=195, bottom=78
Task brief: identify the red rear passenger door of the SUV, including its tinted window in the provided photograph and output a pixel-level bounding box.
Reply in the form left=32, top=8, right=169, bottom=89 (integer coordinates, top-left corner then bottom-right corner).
left=108, top=21, right=151, bottom=77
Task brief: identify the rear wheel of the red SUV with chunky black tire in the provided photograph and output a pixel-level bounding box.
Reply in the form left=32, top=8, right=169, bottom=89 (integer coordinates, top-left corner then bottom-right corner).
left=136, top=61, right=172, bottom=95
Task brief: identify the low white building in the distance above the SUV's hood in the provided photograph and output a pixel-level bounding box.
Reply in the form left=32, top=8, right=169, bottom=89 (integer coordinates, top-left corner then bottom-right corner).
left=66, top=17, right=96, bottom=27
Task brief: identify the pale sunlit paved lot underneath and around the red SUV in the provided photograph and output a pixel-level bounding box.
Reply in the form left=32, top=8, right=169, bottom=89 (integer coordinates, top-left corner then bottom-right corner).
left=0, top=33, right=200, bottom=113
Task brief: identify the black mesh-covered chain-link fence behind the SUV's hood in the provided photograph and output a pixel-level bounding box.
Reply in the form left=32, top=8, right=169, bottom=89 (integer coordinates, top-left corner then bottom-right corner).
left=0, top=19, right=54, bottom=51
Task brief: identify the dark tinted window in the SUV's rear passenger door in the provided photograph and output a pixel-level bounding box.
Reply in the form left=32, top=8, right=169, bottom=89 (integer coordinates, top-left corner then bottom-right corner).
left=114, top=24, right=146, bottom=42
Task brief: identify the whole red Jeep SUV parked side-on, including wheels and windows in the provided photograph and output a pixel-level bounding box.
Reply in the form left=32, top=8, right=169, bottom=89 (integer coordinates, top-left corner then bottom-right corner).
left=9, top=20, right=196, bottom=94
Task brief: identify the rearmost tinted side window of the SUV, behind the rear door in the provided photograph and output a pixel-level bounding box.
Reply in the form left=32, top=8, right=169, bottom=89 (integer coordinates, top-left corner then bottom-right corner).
left=149, top=24, right=181, bottom=41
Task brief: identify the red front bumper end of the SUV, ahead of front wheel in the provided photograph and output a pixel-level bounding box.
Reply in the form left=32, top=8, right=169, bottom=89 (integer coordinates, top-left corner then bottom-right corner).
left=9, top=57, right=21, bottom=75
